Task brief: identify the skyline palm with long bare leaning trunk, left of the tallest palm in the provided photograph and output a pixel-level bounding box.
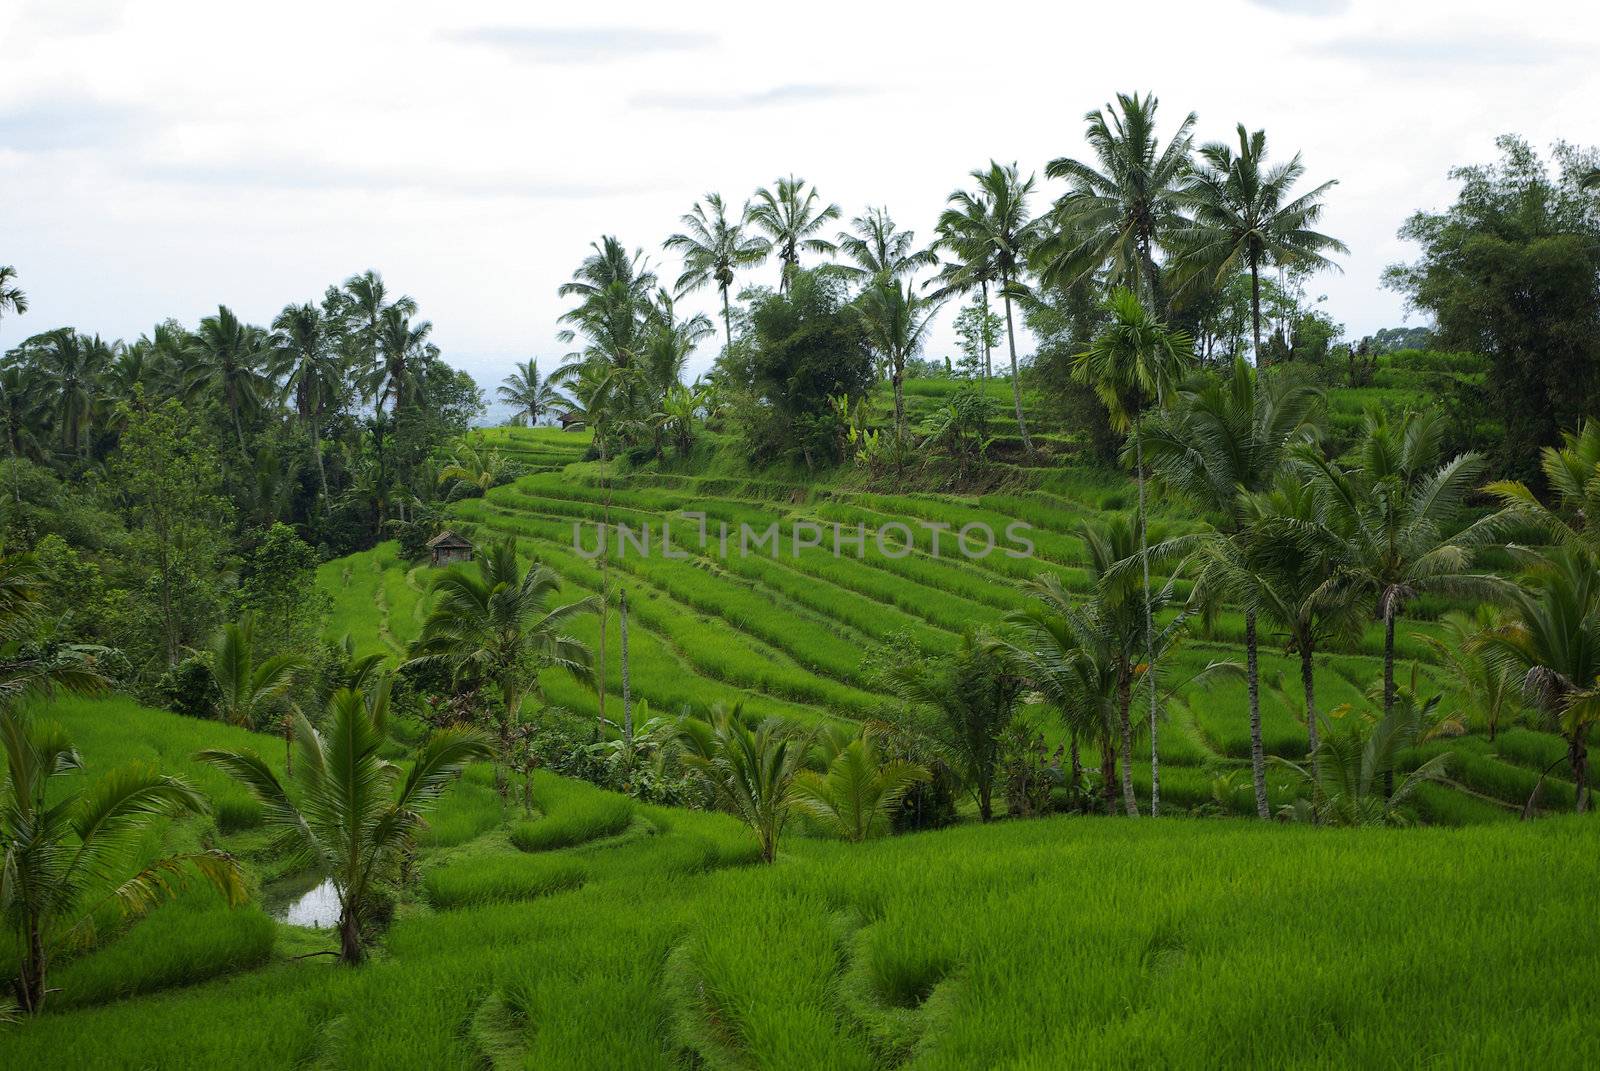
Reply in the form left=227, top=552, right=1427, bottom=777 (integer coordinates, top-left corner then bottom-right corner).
left=939, top=160, right=1038, bottom=458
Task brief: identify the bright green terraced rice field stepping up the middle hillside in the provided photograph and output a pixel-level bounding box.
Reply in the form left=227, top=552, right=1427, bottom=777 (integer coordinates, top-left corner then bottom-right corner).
left=322, top=409, right=1571, bottom=823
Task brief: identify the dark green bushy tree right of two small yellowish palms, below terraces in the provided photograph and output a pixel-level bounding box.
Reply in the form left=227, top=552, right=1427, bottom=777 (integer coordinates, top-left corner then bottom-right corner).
left=886, top=634, right=1022, bottom=821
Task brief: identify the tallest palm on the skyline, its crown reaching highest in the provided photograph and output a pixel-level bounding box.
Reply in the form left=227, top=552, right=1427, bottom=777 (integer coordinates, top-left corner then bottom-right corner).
left=1040, top=93, right=1197, bottom=317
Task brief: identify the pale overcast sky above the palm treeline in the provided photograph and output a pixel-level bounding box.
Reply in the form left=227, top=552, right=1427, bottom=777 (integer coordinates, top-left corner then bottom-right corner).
left=0, top=0, right=1600, bottom=386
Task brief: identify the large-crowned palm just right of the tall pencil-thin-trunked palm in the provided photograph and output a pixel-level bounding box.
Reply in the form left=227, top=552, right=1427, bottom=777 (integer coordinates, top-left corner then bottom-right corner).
left=1141, top=360, right=1322, bottom=818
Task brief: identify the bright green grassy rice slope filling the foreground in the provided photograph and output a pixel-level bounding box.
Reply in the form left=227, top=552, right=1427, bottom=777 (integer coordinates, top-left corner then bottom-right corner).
left=0, top=701, right=1600, bottom=1069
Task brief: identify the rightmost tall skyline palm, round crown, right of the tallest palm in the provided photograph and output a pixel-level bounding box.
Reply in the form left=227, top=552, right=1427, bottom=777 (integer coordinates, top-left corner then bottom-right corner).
left=1178, top=123, right=1349, bottom=365
